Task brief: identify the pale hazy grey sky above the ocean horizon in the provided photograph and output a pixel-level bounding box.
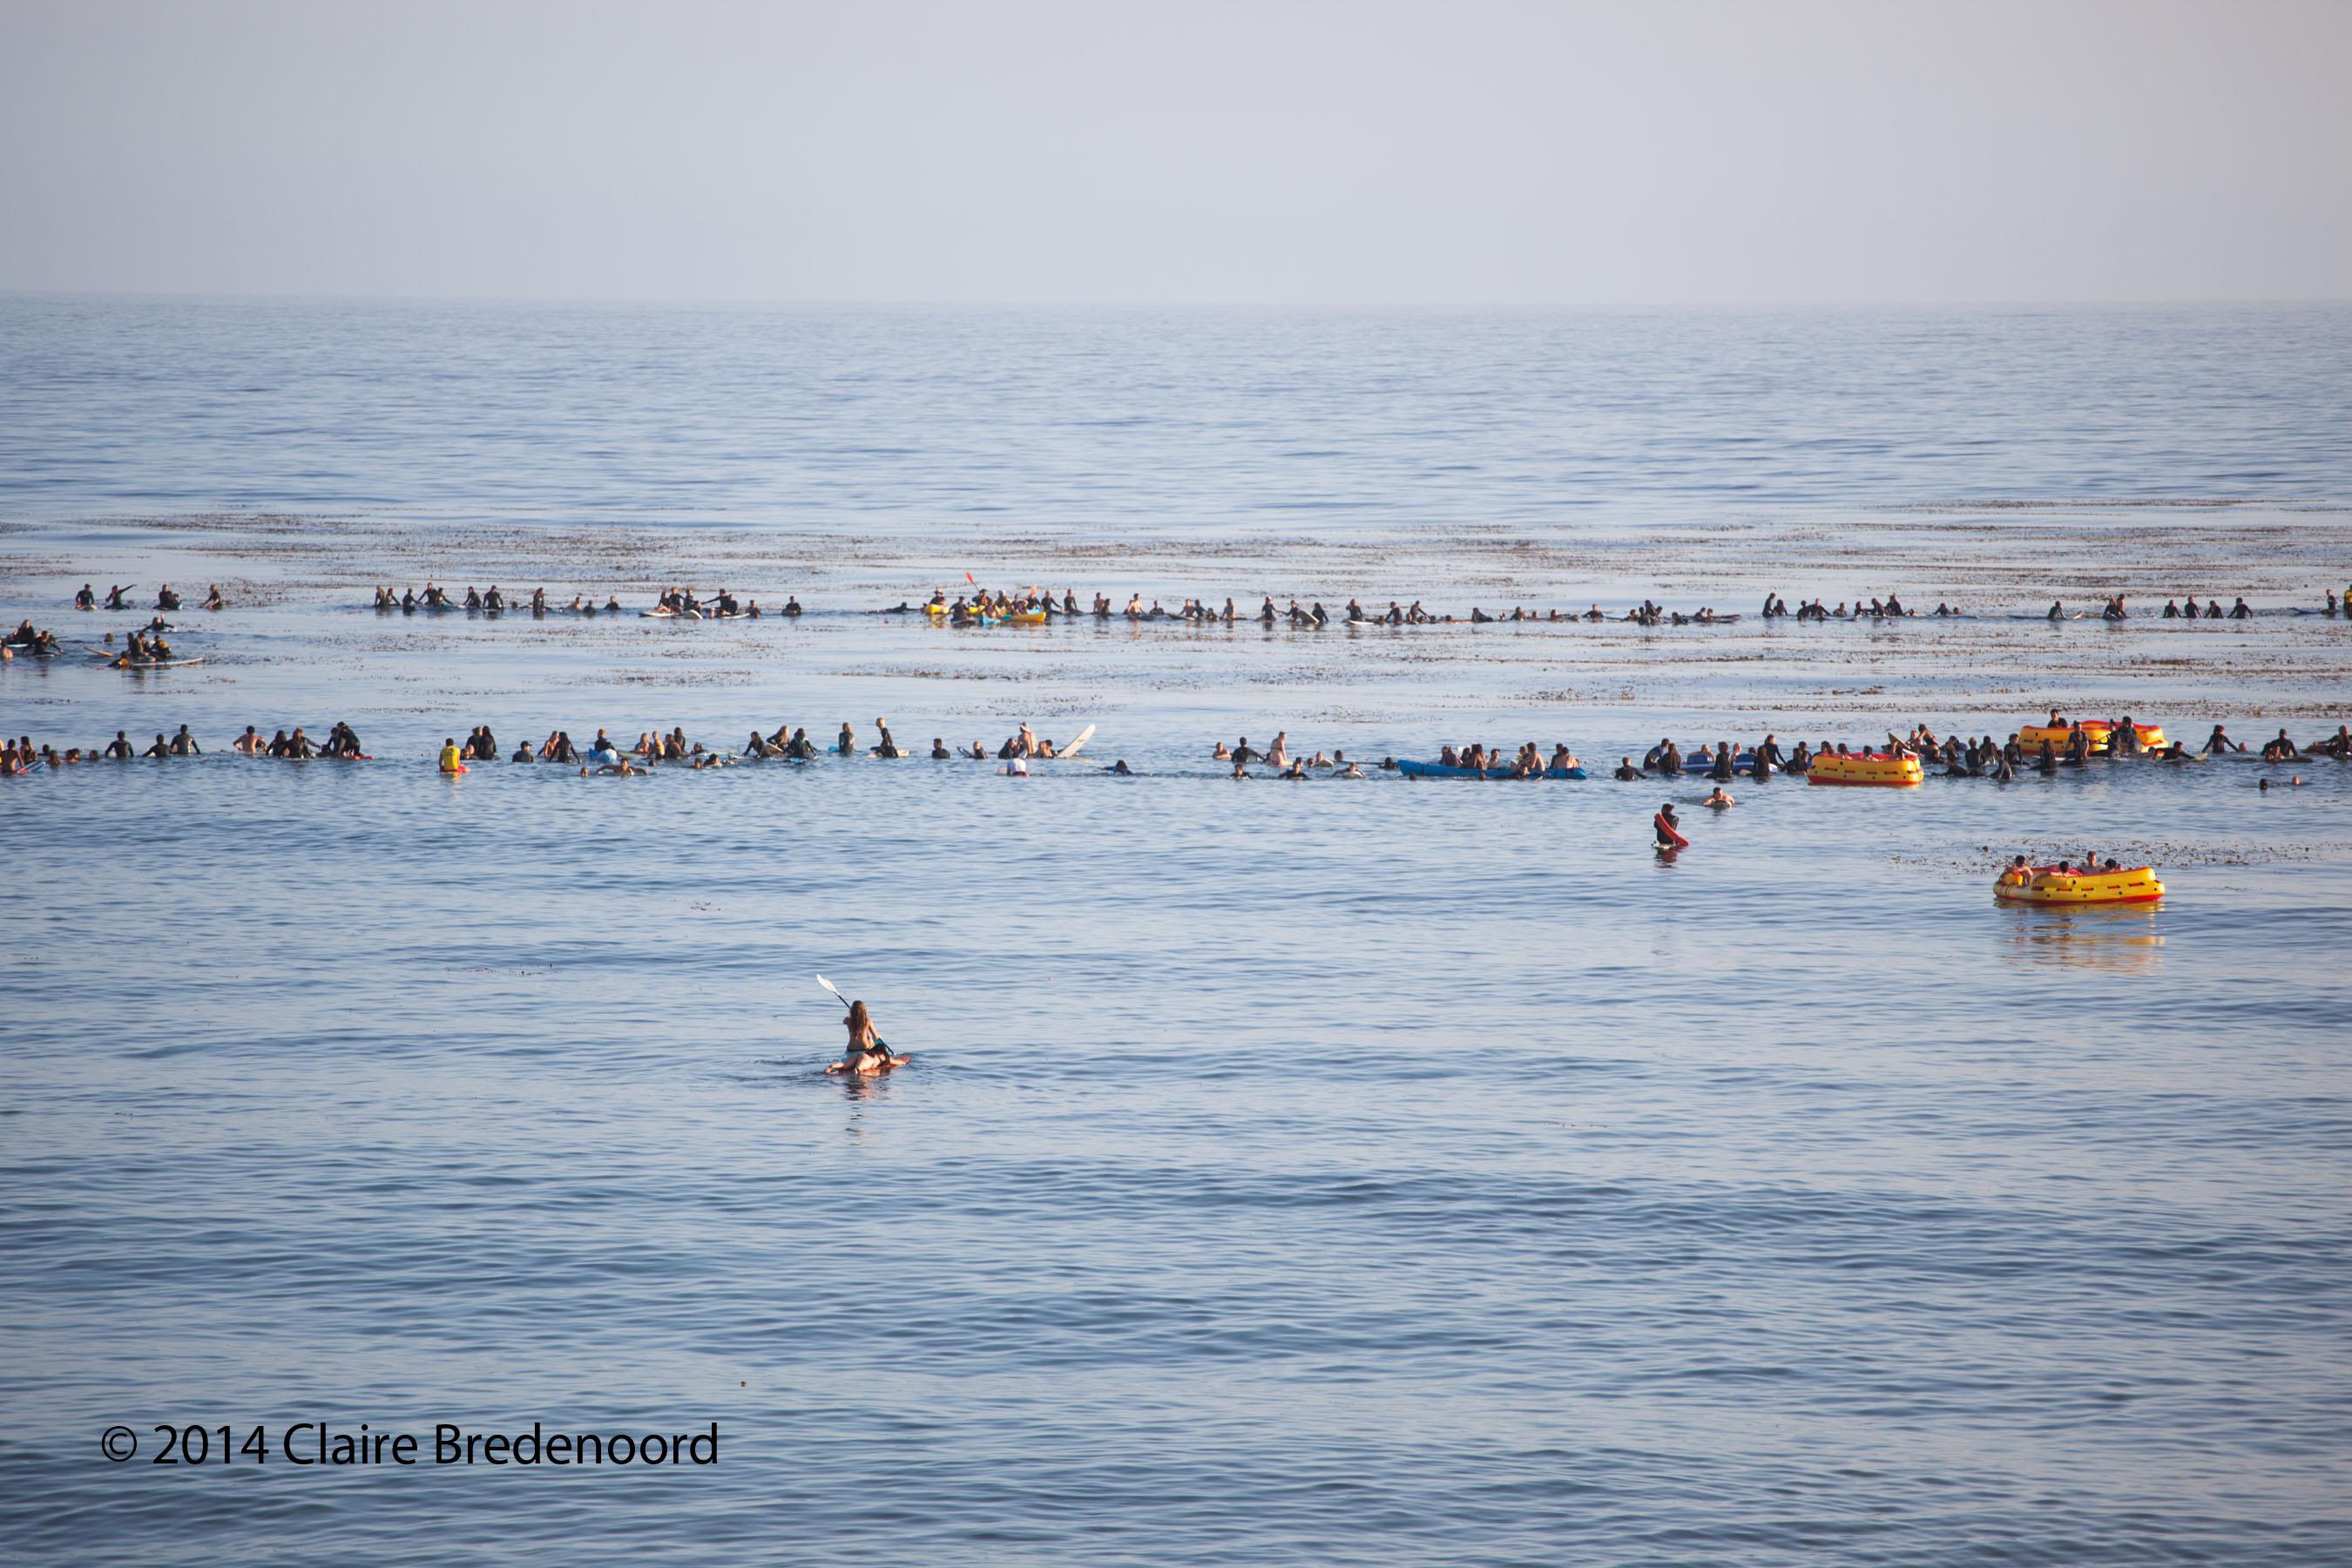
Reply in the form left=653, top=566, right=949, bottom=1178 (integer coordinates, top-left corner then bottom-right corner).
left=0, top=0, right=2352, bottom=303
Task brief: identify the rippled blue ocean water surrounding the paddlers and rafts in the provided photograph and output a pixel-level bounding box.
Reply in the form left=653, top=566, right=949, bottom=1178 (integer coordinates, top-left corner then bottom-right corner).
left=0, top=299, right=2352, bottom=1565
